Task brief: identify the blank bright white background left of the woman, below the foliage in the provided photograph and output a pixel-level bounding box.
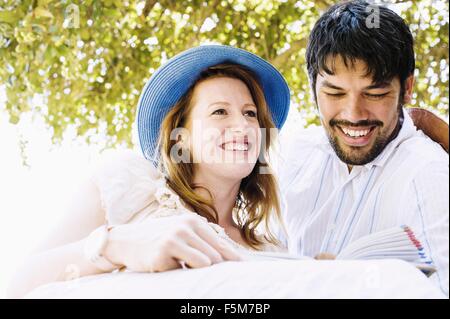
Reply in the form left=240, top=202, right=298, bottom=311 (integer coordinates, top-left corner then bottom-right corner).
left=0, top=86, right=123, bottom=298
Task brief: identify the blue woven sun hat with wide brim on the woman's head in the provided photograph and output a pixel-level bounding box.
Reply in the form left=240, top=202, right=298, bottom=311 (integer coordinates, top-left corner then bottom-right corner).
left=136, top=45, right=290, bottom=163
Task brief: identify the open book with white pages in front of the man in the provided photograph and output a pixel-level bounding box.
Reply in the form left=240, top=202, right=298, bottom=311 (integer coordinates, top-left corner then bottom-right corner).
left=244, top=226, right=436, bottom=276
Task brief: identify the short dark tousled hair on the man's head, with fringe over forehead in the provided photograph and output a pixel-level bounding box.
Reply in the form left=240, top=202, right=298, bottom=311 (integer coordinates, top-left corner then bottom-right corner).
left=306, top=1, right=415, bottom=100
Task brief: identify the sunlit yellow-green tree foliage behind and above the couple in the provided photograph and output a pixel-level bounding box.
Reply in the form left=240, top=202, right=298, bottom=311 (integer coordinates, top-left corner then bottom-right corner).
left=0, top=0, right=448, bottom=145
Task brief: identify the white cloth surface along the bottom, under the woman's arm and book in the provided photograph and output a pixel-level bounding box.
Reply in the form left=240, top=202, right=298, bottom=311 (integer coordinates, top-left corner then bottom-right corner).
left=26, top=260, right=445, bottom=299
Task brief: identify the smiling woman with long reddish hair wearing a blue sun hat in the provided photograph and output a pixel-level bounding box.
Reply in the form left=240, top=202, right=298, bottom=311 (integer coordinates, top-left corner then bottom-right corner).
left=10, top=45, right=289, bottom=296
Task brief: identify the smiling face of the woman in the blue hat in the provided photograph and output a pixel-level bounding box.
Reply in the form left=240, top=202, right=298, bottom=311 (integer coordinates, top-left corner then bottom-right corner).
left=188, top=77, right=261, bottom=180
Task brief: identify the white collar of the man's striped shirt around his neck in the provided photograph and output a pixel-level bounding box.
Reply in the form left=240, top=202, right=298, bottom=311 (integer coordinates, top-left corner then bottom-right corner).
left=317, top=109, right=416, bottom=169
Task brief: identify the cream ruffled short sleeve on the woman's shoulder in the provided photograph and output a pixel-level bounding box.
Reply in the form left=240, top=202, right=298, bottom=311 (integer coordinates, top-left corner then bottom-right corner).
left=92, top=150, right=188, bottom=226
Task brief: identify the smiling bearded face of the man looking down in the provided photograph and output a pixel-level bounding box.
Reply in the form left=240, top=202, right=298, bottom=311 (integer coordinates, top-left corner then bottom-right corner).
left=315, top=56, right=413, bottom=165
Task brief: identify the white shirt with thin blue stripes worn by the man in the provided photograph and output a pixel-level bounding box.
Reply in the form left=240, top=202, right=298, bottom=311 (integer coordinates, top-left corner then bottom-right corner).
left=277, top=111, right=449, bottom=295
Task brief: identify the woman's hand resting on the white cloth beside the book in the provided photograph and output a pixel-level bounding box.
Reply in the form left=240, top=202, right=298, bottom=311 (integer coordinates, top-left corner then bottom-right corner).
left=105, top=214, right=240, bottom=272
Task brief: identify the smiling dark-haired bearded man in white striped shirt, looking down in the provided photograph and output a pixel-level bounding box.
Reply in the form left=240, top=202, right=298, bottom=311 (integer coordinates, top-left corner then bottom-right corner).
left=279, top=1, right=449, bottom=295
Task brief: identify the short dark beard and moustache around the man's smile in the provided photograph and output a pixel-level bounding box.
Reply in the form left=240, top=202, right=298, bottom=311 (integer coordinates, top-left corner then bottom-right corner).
left=326, top=105, right=403, bottom=166
